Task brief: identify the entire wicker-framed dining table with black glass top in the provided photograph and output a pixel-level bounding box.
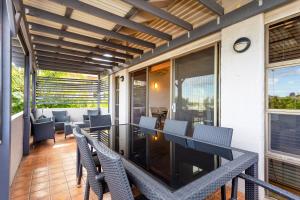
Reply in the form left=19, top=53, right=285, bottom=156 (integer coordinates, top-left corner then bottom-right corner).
left=74, top=124, right=258, bottom=200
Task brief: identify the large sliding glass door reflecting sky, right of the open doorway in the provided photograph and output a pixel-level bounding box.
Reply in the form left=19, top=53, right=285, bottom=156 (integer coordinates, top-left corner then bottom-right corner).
left=172, top=47, right=217, bottom=134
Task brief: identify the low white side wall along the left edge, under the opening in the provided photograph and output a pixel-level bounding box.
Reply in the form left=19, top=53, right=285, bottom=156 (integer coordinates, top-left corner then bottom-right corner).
left=10, top=112, right=24, bottom=185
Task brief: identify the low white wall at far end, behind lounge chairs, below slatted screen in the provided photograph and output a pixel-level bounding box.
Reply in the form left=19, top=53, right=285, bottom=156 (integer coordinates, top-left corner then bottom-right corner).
left=36, top=108, right=107, bottom=122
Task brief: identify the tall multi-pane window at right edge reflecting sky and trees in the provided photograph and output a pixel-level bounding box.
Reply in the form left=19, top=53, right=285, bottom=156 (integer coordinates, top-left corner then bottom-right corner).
left=266, top=16, right=300, bottom=199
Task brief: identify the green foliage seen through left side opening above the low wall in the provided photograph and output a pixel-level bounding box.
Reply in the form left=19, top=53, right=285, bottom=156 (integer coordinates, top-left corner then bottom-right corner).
left=11, top=65, right=24, bottom=114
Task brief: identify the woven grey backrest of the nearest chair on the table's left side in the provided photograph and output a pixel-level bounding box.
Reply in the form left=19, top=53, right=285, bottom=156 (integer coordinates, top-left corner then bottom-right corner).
left=94, top=141, right=134, bottom=200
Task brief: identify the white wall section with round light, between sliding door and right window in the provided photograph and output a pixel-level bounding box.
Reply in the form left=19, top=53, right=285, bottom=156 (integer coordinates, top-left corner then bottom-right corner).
left=220, top=14, right=265, bottom=198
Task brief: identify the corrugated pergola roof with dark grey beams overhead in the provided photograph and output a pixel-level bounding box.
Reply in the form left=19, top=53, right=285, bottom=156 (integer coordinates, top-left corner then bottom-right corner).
left=19, top=0, right=224, bottom=73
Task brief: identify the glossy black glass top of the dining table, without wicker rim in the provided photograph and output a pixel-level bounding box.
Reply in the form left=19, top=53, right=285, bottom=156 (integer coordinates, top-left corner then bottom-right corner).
left=81, top=124, right=244, bottom=191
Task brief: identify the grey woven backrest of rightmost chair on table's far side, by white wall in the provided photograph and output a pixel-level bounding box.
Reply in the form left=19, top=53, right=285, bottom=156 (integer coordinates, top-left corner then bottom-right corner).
left=193, top=124, right=233, bottom=147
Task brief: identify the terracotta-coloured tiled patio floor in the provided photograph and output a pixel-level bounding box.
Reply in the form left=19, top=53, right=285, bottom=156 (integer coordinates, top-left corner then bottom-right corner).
left=11, top=134, right=244, bottom=200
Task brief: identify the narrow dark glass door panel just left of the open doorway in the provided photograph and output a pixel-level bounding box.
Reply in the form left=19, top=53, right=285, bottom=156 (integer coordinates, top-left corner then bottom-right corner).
left=131, top=69, right=147, bottom=124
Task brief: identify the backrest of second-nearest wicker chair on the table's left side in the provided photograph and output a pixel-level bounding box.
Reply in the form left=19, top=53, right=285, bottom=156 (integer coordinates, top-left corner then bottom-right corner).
left=73, top=128, right=103, bottom=199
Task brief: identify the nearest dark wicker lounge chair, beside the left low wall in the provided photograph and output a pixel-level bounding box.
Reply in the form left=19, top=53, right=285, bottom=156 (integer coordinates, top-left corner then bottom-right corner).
left=30, top=113, right=55, bottom=144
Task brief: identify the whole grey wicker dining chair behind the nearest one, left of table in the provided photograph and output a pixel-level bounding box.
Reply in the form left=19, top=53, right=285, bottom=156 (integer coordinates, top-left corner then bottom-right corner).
left=73, top=131, right=104, bottom=200
